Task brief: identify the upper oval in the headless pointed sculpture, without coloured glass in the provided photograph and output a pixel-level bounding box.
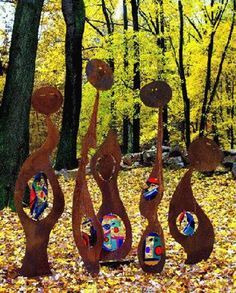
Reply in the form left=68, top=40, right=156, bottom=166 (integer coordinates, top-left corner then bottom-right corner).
left=96, top=154, right=116, bottom=181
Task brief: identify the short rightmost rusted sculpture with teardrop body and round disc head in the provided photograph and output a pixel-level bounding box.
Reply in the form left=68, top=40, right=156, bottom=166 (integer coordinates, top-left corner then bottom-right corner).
left=168, top=137, right=222, bottom=264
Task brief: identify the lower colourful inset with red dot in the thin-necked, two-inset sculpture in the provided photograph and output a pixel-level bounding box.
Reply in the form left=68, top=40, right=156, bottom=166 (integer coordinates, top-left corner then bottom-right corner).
left=144, top=232, right=163, bottom=266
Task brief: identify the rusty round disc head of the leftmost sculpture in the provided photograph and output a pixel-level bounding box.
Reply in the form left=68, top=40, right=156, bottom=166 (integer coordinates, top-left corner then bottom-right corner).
left=32, top=86, right=63, bottom=115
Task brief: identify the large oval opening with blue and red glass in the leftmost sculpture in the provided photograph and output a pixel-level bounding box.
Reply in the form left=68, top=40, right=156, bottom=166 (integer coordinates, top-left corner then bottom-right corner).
left=23, top=172, right=53, bottom=221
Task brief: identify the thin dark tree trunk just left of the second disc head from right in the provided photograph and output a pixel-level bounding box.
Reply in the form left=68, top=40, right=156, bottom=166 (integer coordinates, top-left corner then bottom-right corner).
left=131, top=0, right=141, bottom=153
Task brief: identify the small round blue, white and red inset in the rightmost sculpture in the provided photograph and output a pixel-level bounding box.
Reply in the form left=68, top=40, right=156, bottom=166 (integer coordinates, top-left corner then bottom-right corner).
left=176, top=211, right=198, bottom=236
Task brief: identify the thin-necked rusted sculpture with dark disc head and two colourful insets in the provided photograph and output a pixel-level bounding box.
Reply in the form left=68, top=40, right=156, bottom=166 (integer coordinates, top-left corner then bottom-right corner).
left=138, top=81, right=172, bottom=273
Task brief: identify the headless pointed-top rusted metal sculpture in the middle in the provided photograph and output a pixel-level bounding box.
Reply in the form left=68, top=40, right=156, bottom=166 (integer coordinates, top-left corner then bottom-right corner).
left=91, top=130, right=132, bottom=260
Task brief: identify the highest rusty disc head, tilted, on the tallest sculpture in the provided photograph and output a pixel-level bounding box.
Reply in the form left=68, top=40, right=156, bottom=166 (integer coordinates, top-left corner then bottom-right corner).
left=86, top=59, right=113, bottom=91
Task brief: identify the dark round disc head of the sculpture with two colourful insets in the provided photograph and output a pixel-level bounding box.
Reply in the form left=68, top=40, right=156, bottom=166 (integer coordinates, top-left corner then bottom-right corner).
left=140, top=81, right=172, bottom=108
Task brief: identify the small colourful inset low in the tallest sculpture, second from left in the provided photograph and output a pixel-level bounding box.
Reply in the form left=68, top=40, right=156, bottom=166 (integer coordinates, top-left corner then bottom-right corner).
left=81, top=217, right=97, bottom=247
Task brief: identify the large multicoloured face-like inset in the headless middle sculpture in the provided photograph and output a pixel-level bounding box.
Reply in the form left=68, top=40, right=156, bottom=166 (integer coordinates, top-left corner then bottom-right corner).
left=102, top=213, right=125, bottom=251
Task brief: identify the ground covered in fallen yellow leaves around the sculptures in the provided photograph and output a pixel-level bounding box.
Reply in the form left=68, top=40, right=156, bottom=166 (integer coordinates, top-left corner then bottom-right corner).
left=0, top=168, right=236, bottom=293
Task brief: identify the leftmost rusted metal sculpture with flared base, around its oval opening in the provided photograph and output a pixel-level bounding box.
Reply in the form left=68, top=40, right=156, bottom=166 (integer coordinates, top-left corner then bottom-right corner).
left=15, top=87, right=64, bottom=277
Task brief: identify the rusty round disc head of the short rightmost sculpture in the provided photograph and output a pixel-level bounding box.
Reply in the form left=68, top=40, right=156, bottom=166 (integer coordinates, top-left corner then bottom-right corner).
left=188, top=137, right=223, bottom=172
